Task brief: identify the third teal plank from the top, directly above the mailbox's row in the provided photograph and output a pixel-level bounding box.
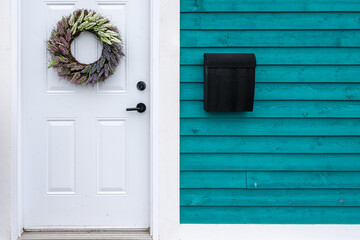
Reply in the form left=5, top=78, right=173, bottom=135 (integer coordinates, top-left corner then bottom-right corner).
left=180, top=29, right=360, bottom=47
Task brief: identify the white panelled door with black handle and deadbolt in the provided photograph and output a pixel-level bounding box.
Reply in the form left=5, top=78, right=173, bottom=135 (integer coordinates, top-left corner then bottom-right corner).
left=21, top=0, right=150, bottom=229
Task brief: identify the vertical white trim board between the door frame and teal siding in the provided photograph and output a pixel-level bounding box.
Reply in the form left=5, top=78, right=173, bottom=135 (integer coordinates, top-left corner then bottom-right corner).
left=157, top=0, right=180, bottom=240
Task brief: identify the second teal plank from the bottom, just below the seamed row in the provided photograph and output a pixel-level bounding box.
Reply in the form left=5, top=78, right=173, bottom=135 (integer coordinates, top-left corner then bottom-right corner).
left=180, top=189, right=360, bottom=207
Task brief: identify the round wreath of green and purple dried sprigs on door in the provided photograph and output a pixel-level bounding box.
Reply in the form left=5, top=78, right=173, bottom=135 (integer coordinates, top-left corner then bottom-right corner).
left=46, top=9, right=125, bottom=86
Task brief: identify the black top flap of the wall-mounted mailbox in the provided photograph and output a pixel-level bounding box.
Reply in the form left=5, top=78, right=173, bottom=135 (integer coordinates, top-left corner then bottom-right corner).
left=204, top=53, right=256, bottom=68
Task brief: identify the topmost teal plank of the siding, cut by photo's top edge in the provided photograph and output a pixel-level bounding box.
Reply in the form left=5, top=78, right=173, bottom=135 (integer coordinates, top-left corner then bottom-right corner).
left=180, top=0, right=360, bottom=12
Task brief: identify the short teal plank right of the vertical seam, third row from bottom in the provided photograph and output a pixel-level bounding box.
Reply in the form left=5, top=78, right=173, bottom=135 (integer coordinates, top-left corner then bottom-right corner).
left=247, top=172, right=360, bottom=189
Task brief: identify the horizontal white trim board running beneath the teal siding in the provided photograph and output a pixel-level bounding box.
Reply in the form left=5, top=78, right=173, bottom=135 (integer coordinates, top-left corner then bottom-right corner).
left=177, top=224, right=360, bottom=240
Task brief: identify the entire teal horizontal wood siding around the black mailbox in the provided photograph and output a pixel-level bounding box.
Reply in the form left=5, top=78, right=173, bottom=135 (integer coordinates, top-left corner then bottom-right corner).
left=180, top=0, right=360, bottom=224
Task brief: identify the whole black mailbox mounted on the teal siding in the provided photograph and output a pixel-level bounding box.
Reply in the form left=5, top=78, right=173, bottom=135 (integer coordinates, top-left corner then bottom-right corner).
left=204, top=53, right=256, bottom=112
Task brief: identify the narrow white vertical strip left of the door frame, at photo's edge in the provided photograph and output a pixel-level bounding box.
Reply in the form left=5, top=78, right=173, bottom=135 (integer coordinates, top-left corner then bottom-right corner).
left=0, top=0, right=11, bottom=240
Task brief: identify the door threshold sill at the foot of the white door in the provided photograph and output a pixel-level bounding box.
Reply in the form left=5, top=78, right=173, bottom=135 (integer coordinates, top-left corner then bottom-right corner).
left=19, top=229, right=152, bottom=240
